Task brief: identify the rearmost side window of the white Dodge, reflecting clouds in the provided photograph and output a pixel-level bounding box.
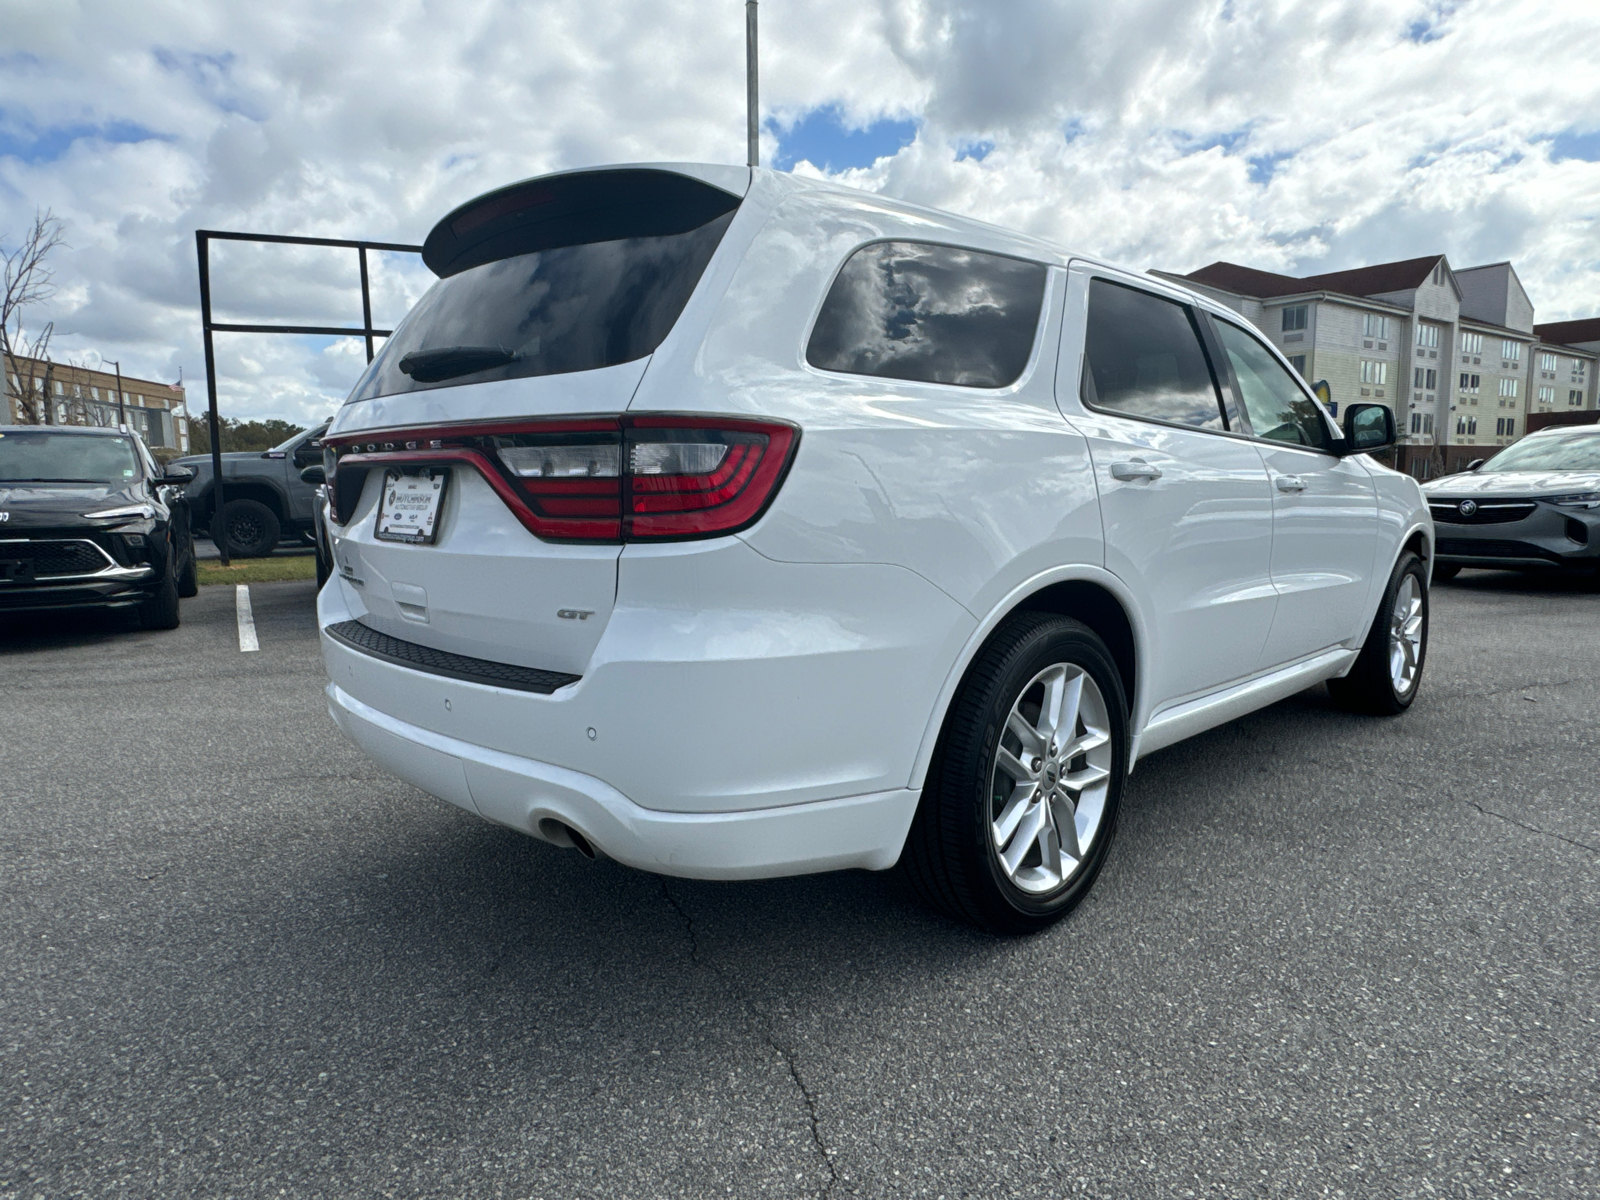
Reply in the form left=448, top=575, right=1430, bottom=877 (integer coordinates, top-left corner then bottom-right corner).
left=805, top=242, right=1046, bottom=387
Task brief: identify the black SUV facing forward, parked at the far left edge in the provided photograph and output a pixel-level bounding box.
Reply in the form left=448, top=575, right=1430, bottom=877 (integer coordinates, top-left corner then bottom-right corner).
left=0, top=426, right=198, bottom=629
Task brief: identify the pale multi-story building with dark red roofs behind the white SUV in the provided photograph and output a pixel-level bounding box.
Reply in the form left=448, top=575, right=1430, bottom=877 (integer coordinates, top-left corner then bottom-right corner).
left=1152, top=254, right=1600, bottom=478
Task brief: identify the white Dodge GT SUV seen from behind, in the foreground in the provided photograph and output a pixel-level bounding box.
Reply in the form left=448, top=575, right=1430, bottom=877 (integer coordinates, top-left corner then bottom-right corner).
left=318, top=165, right=1434, bottom=931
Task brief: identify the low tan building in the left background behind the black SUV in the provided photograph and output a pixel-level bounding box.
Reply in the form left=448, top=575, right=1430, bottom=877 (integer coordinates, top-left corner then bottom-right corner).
left=0, top=358, right=189, bottom=453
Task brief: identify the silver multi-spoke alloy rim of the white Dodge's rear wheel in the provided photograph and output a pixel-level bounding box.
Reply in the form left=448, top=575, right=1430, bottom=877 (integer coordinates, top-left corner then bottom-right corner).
left=987, top=662, right=1114, bottom=894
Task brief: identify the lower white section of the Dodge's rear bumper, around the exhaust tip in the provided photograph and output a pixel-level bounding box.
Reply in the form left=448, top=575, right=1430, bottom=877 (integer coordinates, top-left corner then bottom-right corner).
left=328, top=683, right=917, bottom=880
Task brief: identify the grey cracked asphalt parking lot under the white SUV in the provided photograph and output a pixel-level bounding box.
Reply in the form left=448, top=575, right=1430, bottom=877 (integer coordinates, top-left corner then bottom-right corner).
left=0, top=573, right=1600, bottom=1200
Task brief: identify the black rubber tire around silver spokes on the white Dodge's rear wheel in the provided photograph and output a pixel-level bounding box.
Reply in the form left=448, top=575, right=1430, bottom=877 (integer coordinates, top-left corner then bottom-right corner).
left=901, top=613, right=1128, bottom=934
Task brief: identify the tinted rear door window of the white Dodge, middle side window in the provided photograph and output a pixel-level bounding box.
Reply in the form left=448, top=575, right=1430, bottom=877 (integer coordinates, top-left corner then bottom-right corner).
left=1083, top=278, right=1224, bottom=429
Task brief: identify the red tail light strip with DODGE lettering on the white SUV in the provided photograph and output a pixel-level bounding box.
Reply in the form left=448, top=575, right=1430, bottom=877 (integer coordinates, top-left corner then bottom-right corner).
left=334, top=416, right=798, bottom=542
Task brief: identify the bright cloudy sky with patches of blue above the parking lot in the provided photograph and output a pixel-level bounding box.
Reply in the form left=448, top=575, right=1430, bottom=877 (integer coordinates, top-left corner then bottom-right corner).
left=0, top=0, right=1600, bottom=422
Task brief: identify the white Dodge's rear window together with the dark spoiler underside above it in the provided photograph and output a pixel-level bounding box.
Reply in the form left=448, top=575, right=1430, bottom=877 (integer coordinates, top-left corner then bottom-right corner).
left=350, top=170, right=739, bottom=402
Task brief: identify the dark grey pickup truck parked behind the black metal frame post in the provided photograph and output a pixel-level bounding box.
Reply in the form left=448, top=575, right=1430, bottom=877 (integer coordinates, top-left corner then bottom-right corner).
left=178, top=424, right=328, bottom=558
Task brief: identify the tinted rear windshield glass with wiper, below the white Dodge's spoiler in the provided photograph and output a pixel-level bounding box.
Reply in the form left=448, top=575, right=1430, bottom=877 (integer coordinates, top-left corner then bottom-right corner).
left=347, top=211, right=733, bottom=403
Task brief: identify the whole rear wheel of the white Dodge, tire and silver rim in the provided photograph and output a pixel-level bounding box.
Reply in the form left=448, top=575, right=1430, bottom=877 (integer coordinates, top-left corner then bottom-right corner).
left=904, top=613, right=1128, bottom=934
